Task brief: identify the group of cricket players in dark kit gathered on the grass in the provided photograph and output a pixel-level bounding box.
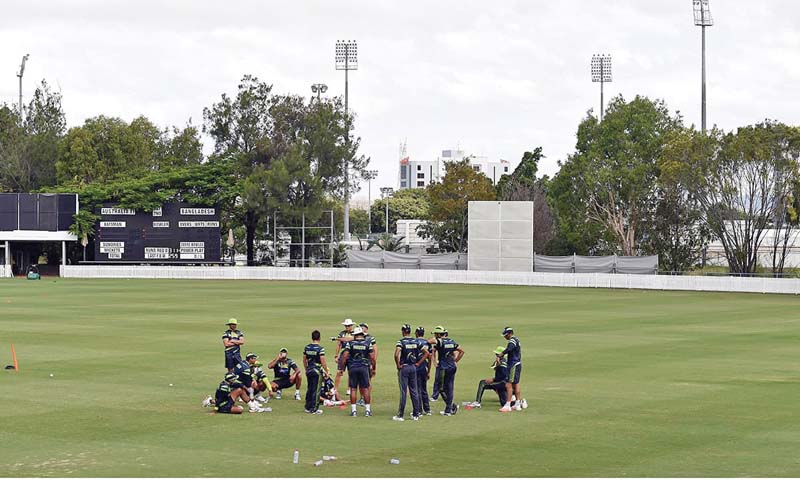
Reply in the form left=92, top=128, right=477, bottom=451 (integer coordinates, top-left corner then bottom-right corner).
left=203, top=318, right=527, bottom=421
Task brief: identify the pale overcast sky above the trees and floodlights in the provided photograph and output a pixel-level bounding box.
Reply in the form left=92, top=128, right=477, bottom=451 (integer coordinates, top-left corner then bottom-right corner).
left=0, top=0, right=800, bottom=200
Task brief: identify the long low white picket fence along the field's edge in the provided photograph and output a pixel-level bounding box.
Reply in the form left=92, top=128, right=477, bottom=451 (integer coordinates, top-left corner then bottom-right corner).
left=61, top=265, right=800, bottom=295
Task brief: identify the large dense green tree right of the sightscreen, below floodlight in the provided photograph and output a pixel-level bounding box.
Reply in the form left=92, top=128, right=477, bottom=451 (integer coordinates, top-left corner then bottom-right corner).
left=556, top=96, right=682, bottom=255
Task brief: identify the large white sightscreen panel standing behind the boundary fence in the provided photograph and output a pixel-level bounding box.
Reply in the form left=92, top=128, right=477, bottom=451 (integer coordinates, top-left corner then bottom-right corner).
left=468, top=202, right=533, bottom=272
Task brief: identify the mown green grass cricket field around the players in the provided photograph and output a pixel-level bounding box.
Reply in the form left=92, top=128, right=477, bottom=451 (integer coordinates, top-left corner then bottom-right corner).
left=0, top=279, right=800, bottom=477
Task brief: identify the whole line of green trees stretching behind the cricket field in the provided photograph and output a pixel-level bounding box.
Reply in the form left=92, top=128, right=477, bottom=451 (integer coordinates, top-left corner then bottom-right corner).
left=0, top=76, right=800, bottom=273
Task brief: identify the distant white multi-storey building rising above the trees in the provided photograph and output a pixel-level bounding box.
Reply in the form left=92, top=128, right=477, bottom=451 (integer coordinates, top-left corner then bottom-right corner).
left=400, top=147, right=511, bottom=190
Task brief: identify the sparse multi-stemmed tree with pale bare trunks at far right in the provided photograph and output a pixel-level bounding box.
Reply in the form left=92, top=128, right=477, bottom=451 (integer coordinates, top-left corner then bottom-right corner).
left=669, top=121, right=800, bottom=273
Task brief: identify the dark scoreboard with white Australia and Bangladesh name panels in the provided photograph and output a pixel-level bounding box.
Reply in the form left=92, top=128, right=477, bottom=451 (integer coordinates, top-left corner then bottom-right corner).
left=94, top=203, right=220, bottom=263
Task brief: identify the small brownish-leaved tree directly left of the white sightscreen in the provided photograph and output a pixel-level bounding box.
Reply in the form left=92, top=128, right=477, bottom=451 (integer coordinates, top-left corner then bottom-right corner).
left=419, top=159, right=497, bottom=252
